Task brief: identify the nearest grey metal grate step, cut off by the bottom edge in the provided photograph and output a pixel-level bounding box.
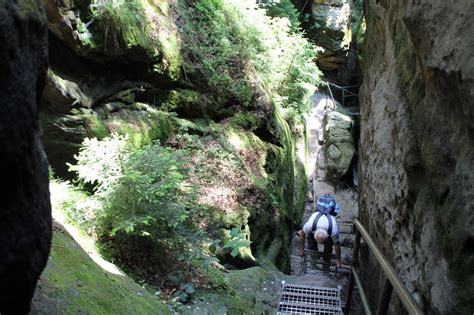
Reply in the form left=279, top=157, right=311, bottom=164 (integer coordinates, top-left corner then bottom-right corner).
left=277, top=284, right=342, bottom=315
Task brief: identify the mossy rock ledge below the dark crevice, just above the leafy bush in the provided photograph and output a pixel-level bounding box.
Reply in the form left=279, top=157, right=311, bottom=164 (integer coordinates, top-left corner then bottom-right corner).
left=40, top=102, right=177, bottom=178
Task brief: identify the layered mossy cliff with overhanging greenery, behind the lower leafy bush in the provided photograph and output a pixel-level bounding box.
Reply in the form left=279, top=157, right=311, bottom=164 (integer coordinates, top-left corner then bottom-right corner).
left=40, top=0, right=320, bottom=294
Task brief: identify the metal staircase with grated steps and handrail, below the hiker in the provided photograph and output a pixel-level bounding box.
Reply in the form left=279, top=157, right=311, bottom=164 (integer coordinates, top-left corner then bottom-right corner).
left=277, top=219, right=423, bottom=315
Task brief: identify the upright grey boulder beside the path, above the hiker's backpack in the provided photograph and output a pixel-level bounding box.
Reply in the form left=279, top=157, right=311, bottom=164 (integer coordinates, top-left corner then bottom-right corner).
left=324, top=110, right=355, bottom=179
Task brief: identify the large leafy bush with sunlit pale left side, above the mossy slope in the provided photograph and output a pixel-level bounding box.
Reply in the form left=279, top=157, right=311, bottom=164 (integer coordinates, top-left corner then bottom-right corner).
left=63, top=134, right=250, bottom=301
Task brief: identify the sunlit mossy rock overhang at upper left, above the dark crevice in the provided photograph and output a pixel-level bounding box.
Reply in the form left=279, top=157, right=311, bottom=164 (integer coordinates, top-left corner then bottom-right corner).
left=44, top=0, right=181, bottom=81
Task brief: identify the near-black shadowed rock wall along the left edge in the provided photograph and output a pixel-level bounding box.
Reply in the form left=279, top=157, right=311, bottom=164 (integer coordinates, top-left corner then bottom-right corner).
left=0, top=0, right=51, bottom=315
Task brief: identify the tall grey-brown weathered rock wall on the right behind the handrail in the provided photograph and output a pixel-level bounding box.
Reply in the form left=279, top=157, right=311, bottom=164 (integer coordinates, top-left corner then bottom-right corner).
left=359, top=0, right=474, bottom=314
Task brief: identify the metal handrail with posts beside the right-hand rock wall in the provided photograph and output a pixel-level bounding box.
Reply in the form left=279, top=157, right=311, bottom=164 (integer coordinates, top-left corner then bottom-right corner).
left=346, top=219, right=423, bottom=315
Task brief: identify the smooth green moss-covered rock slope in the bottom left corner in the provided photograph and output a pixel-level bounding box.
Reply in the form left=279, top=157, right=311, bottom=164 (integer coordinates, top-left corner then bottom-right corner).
left=33, top=226, right=171, bottom=314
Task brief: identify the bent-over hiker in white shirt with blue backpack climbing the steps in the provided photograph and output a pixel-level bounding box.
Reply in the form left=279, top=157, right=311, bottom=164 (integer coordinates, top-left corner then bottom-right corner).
left=297, top=194, right=341, bottom=268
